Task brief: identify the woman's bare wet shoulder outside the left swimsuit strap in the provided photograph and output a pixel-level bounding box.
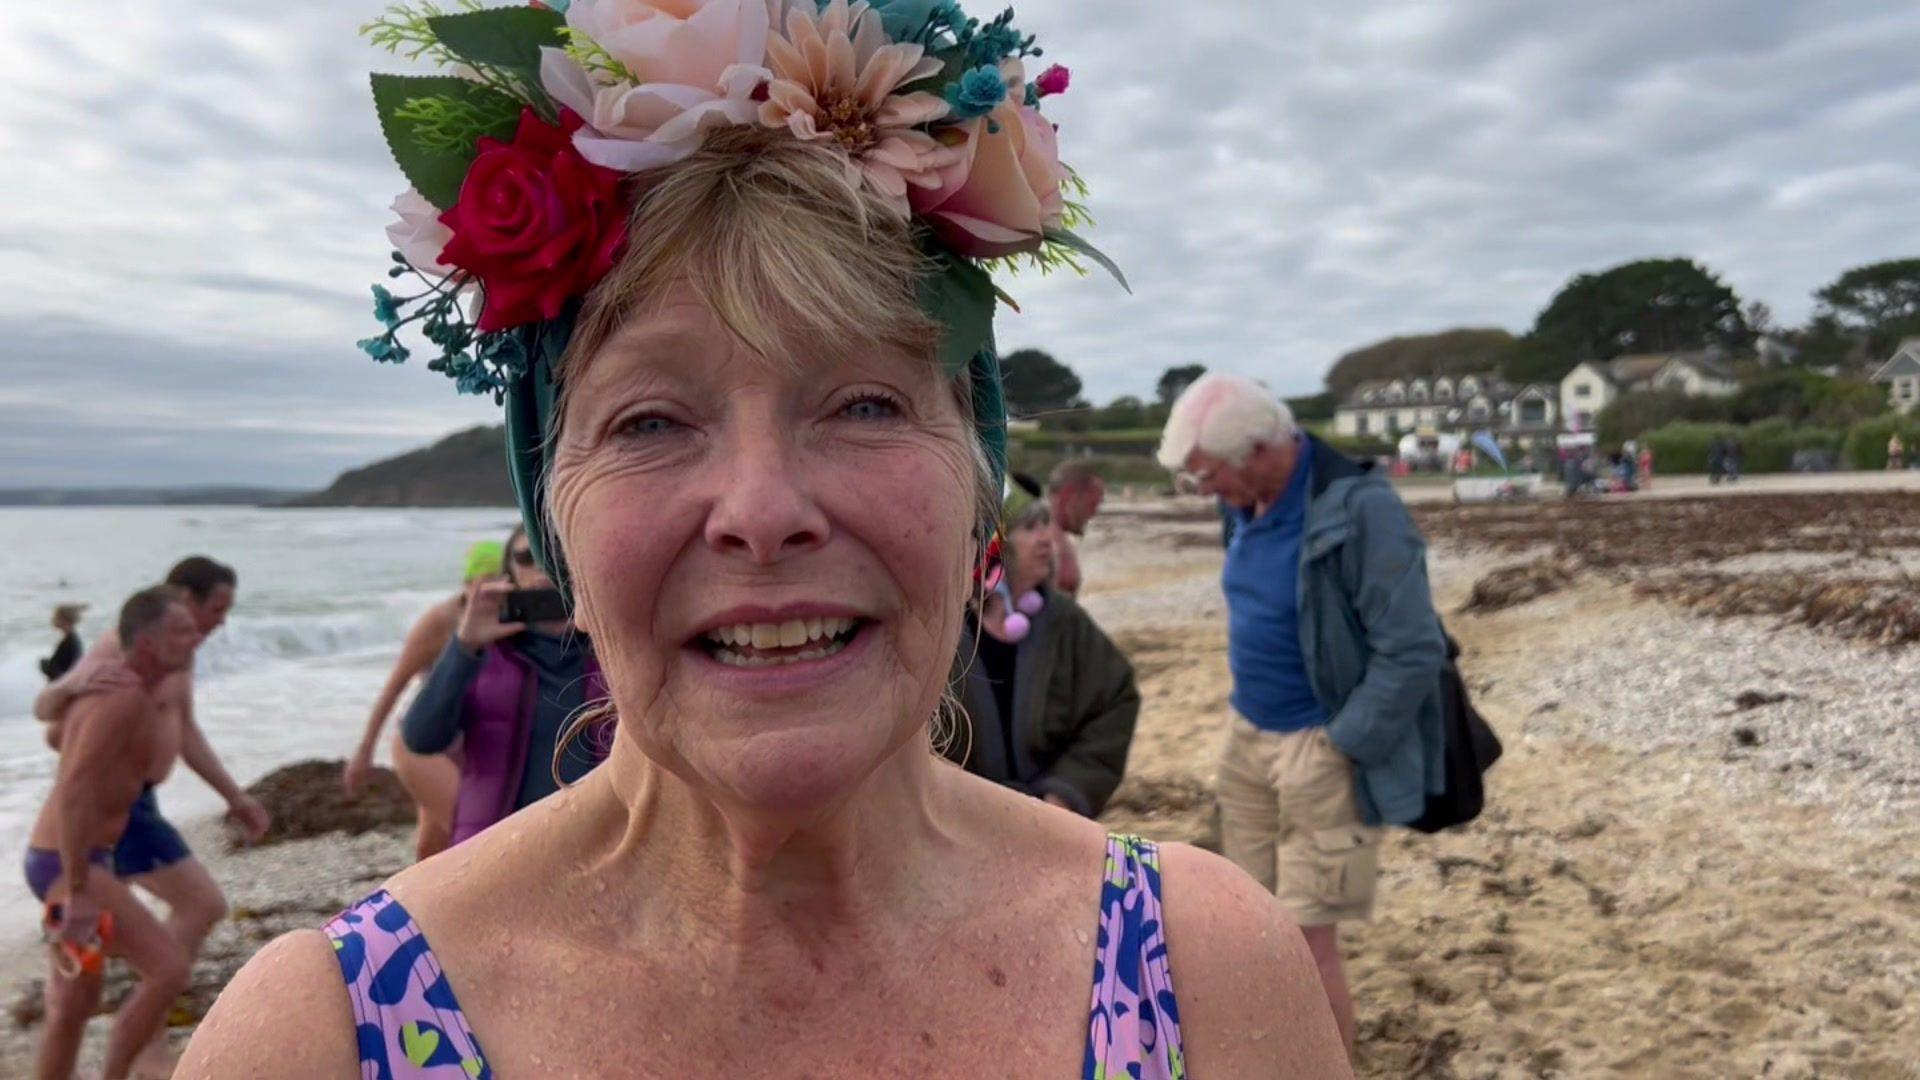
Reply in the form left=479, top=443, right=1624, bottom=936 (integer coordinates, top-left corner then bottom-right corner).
left=177, top=930, right=361, bottom=1080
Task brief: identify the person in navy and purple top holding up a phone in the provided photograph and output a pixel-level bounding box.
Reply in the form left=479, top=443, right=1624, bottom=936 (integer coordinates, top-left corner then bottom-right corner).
left=399, top=528, right=607, bottom=844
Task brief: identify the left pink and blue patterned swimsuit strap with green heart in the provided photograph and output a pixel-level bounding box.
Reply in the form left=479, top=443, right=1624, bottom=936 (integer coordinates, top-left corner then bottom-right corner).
left=326, top=890, right=493, bottom=1080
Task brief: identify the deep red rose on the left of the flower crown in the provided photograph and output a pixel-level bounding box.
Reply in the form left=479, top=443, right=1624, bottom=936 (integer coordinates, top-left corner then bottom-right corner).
left=440, top=110, right=628, bottom=332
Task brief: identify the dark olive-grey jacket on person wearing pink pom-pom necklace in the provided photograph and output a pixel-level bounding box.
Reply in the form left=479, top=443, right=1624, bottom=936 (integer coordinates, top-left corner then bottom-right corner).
left=947, top=590, right=1140, bottom=817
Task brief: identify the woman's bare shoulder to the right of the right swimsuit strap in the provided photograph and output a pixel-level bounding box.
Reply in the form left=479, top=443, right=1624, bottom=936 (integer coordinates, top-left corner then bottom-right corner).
left=1160, top=844, right=1352, bottom=1078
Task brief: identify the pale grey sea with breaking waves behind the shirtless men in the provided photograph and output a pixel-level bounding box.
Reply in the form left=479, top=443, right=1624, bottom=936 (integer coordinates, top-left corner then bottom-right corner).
left=0, top=507, right=516, bottom=920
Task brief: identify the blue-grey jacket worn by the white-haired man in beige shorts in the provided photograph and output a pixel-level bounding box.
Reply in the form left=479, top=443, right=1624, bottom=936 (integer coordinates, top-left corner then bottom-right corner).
left=1300, top=436, right=1446, bottom=824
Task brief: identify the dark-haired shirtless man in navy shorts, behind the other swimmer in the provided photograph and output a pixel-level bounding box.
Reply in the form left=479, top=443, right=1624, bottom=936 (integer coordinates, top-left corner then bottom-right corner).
left=33, top=555, right=271, bottom=1067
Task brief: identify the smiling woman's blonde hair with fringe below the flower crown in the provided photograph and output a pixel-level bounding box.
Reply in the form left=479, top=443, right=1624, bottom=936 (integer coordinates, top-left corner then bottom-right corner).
left=545, top=127, right=1000, bottom=776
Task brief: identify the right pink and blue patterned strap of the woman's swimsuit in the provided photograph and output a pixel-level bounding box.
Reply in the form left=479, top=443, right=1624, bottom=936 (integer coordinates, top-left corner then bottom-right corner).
left=1081, top=834, right=1187, bottom=1080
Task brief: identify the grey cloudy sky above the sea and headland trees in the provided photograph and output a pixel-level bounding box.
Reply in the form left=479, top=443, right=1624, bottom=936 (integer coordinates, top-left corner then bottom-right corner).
left=0, top=0, right=1920, bottom=486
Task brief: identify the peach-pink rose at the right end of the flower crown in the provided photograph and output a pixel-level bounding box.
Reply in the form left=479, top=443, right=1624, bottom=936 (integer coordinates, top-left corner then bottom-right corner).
left=908, top=98, right=1068, bottom=259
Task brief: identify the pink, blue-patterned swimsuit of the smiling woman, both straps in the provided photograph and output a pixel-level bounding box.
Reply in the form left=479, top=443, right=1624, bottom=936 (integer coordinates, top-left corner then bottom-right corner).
left=326, top=836, right=1187, bottom=1080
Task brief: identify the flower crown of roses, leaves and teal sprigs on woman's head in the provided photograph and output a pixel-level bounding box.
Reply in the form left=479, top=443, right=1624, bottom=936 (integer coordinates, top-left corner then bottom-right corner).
left=359, top=0, right=1125, bottom=400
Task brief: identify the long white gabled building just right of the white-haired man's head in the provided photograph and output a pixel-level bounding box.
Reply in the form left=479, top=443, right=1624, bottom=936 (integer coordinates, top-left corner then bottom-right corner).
left=1332, top=375, right=1559, bottom=438
